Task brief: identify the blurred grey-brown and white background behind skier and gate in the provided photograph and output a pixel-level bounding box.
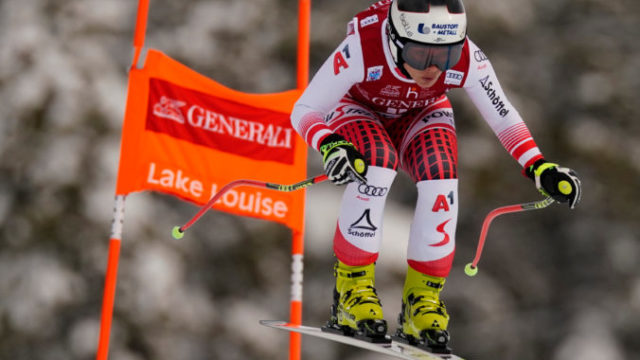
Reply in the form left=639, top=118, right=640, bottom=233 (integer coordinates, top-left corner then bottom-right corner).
left=0, top=0, right=640, bottom=360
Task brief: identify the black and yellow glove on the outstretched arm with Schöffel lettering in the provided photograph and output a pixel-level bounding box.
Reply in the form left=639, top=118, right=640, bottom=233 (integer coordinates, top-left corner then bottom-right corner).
left=524, top=159, right=582, bottom=209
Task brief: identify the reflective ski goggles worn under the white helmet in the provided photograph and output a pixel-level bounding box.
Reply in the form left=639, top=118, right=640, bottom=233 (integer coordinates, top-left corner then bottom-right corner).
left=401, top=40, right=464, bottom=71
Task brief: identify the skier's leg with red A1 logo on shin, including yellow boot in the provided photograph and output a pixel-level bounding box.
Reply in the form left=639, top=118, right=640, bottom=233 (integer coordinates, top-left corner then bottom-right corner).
left=398, top=102, right=458, bottom=352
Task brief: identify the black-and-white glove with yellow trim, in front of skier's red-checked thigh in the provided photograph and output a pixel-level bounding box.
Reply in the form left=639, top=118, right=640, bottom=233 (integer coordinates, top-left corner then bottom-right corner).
left=320, top=134, right=367, bottom=185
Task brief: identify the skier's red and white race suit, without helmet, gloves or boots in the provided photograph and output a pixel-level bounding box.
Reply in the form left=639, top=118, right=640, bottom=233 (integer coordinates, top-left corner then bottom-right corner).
left=291, top=0, right=542, bottom=277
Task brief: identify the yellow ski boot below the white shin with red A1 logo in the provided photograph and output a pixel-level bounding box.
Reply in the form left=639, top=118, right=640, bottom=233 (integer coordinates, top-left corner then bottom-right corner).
left=394, top=267, right=451, bottom=354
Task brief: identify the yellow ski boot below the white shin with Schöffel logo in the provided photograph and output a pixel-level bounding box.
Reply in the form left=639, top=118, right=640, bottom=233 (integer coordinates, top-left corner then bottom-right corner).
left=322, top=261, right=391, bottom=343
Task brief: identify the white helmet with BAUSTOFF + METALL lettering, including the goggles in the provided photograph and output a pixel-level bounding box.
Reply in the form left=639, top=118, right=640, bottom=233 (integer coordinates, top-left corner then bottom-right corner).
left=387, top=0, right=467, bottom=76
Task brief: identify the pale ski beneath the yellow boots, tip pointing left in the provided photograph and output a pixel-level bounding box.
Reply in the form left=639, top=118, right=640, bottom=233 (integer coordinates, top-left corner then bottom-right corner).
left=260, top=320, right=464, bottom=360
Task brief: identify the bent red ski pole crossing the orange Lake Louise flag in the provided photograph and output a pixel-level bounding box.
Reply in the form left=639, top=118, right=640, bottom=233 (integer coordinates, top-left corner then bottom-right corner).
left=171, top=174, right=328, bottom=239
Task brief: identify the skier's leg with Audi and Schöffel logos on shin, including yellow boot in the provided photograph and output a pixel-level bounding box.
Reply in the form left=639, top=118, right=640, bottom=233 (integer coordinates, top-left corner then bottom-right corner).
left=325, top=102, right=398, bottom=339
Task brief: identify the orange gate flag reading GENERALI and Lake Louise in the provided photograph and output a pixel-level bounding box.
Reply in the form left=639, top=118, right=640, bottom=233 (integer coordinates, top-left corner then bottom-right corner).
left=116, top=50, right=307, bottom=231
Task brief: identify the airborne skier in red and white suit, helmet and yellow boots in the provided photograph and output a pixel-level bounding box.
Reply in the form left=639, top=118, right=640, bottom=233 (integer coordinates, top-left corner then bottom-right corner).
left=291, top=0, right=580, bottom=352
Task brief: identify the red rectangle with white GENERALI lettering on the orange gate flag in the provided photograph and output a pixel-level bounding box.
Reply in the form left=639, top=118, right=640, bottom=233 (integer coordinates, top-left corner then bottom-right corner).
left=146, top=79, right=295, bottom=164
